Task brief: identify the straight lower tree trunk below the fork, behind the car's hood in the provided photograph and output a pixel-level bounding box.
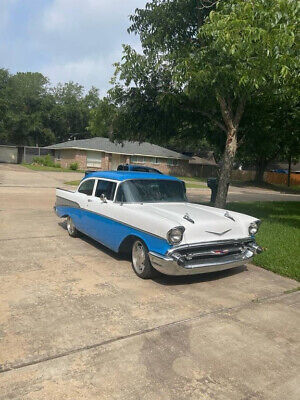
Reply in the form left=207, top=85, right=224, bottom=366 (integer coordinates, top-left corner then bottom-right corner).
left=215, top=129, right=237, bottom=208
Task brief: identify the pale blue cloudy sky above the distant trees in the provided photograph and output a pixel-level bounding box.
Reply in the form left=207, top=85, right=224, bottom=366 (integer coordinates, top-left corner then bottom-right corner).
left=0, top=0, right=146, bottom=95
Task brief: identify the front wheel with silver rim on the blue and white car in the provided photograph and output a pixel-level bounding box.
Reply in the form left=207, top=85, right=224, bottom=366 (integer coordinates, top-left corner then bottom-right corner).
left=131, top=240, right=156, bottom=279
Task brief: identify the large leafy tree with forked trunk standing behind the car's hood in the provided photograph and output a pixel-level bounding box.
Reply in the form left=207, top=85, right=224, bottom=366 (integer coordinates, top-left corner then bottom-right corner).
left=108, top=0, right=299, bottom=207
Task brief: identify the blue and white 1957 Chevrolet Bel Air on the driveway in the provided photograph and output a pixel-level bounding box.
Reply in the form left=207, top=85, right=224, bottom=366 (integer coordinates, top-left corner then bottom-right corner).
left=54, top=171, right=262, bottom=279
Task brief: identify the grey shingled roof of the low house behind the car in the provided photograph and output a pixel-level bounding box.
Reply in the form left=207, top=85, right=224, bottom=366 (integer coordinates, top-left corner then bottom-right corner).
left=46, top=137, right=189, bottom=160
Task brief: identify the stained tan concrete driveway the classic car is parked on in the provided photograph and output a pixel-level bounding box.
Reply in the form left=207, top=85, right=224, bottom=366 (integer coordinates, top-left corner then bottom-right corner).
left=0, top=164, right=300, bottom=400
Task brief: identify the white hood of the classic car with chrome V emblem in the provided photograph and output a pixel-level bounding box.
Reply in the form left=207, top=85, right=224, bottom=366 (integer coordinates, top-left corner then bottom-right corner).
left=143, top=203, right=256, bottom=244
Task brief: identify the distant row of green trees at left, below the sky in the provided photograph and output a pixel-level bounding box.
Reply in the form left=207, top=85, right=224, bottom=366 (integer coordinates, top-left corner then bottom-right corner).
left=0, top=69, right=99, bottom=146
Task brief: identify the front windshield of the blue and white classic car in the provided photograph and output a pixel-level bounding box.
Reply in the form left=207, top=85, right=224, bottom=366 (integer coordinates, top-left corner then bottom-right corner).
left=116, top=179, right=187, bottom=203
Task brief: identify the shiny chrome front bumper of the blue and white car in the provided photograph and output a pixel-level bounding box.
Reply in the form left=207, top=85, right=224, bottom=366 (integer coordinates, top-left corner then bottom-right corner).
left=149, top=239, right=262, bottom=275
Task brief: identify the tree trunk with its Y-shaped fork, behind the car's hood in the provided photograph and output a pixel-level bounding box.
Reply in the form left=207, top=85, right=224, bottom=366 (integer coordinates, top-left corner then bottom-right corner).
left=215, top=94, right=245, bottom=208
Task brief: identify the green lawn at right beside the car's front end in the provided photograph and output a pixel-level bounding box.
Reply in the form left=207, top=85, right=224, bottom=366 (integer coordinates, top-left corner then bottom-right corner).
left=227, top=202, right=300, bottom=281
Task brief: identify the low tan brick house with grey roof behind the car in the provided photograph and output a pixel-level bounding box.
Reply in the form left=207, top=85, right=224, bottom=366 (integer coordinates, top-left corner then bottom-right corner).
left=46, top=137, right=190, bottom=174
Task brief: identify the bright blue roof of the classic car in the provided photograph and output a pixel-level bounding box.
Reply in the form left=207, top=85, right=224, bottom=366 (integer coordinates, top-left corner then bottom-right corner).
left=83, top=171, right=180, bottom=181
